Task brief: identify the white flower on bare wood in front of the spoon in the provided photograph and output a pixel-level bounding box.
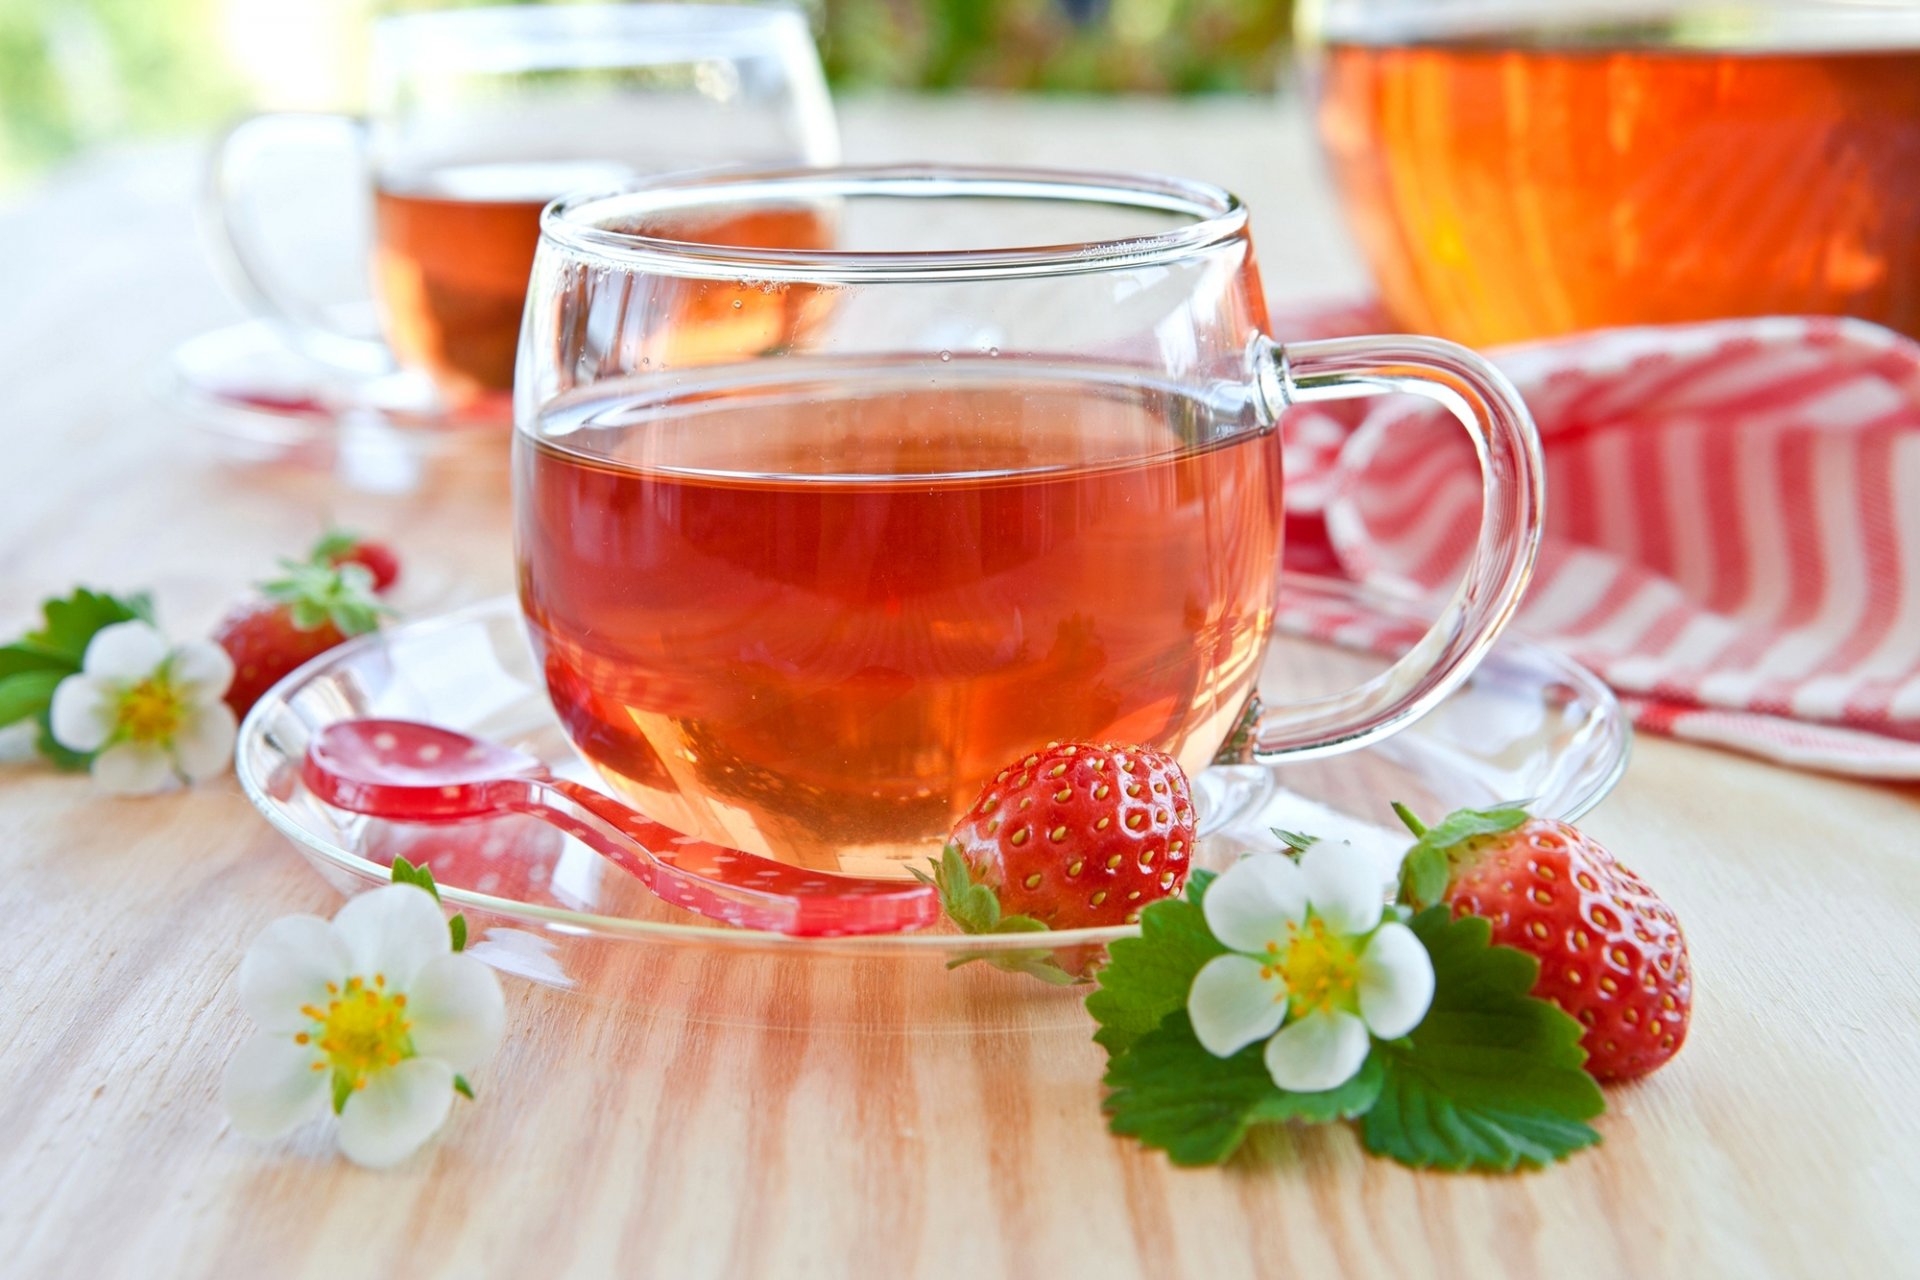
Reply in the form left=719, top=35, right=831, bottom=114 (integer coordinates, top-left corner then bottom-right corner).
left=223, top=885, right=507, bottom=1169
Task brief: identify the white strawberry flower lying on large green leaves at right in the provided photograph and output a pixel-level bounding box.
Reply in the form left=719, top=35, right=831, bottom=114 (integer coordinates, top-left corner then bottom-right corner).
left=1187, top=842, right=1434, bottom=1094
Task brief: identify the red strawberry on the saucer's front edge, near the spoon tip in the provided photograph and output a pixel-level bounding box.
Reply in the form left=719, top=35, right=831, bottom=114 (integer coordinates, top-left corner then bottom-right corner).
left=950, top=743, right=1194, bottom=929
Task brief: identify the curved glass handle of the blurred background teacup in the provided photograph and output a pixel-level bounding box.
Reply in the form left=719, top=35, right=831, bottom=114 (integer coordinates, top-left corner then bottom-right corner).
left=204, top=111, right=394, bottom=374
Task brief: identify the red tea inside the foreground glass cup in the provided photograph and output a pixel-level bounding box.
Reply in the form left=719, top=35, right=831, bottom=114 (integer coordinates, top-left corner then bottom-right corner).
left=516, top=361, right=1281, bottom=869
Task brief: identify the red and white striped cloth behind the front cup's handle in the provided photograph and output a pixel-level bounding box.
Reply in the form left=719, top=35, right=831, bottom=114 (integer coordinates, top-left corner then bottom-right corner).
left=1279, top=311, right=1920, bottom=777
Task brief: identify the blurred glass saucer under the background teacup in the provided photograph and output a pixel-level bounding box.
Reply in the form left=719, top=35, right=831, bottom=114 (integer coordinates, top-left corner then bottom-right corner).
left=159, top=320, right=513, bottom=493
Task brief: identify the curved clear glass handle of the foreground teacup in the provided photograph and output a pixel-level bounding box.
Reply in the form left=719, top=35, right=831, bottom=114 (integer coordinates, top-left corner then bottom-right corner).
left=1221, top=338, right=1546, bottom=764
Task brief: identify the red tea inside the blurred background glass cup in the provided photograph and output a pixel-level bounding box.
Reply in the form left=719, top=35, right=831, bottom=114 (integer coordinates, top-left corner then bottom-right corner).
left=374, top=163, right=826, bottom=401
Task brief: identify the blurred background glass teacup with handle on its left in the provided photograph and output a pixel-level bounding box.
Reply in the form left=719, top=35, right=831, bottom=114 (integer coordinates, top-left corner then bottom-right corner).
left=211, top=4, right=839, bottom=418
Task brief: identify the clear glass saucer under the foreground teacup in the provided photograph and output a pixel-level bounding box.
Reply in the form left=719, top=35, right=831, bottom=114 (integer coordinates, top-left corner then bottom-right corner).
left=236, top=580, right=1628, bottom=1031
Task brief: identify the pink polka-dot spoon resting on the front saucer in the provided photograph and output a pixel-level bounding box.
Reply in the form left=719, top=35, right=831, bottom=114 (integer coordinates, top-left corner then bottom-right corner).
left=301, top=720, right=939, bottom=938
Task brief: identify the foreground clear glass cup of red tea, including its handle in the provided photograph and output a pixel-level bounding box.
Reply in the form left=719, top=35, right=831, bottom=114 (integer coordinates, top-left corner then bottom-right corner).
left=515, top=167, right=1542, bottom=873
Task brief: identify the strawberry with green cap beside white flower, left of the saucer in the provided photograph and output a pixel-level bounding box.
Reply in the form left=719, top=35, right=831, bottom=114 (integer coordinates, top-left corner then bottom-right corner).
left=213, top=560, right=384, bottom=716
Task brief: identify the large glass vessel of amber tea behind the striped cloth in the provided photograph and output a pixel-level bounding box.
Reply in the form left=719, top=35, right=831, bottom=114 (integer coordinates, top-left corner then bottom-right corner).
left=1296, top=0, right=1920, bottom=345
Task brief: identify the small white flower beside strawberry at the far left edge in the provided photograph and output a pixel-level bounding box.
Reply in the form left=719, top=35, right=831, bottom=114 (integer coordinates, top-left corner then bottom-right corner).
left=50, top=622, right=234, bottom=794
